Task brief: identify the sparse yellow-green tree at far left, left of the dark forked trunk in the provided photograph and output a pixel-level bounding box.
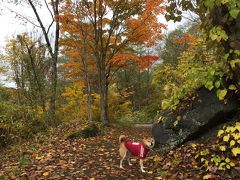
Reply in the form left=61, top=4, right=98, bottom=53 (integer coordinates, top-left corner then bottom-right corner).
left=2, top=33, right=49, bottom=112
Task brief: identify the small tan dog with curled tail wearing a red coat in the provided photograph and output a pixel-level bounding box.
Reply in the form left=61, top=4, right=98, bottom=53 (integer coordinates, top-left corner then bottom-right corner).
left=119, top=135, right=155, bottom=172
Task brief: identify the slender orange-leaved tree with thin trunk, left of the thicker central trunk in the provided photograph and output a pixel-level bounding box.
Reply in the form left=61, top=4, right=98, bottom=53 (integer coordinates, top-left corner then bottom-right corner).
left=61, top=14, right=96, bottom=122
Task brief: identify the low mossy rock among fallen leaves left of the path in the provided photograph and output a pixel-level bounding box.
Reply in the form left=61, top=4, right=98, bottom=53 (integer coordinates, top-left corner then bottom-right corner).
left=64, top=124, right=100, bottom=140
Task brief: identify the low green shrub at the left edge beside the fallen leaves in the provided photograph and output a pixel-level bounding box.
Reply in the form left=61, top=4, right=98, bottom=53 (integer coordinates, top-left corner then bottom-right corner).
left=0, top=101, right=45, bottom=145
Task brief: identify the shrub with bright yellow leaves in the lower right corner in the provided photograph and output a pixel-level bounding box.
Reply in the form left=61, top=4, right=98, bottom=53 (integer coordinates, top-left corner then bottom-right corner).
left=196, top=122, right=240, bottom=171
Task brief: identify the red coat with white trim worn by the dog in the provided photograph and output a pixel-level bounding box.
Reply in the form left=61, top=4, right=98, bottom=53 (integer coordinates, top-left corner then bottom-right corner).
left=124, top=141, right=149, bottom=159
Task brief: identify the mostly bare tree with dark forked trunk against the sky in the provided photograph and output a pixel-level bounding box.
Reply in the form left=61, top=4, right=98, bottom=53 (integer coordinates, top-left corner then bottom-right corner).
left=4, top=0, right=60, bottom=124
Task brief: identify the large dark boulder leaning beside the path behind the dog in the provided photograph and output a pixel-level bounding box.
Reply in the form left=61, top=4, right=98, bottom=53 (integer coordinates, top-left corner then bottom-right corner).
left=152, top=88, right=239, bottom=152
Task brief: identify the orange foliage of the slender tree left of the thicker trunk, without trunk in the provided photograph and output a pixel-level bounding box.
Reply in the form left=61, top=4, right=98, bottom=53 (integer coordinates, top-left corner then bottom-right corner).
left=60, top=0, right=96, bottom=80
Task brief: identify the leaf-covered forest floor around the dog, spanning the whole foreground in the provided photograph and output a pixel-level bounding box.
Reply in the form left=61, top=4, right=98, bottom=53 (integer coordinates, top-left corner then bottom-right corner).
left=0, top=121, right=236, bottom=180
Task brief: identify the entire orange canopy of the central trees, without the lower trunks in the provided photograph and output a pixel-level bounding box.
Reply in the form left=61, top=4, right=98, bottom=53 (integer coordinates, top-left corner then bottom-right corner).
left=60, top=0, right=165, bottom=80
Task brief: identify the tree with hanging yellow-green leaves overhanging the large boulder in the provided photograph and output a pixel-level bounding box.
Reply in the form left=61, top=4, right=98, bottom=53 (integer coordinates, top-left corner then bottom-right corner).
left=166, top=0, right=240, bottom=92
